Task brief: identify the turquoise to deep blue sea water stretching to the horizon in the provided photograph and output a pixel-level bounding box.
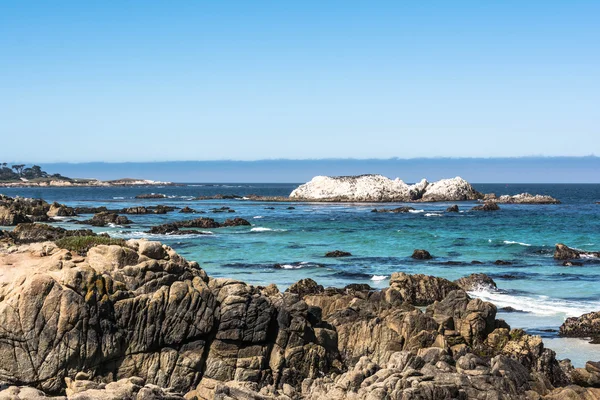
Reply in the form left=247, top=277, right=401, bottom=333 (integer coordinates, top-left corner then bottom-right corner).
left=0, top=184, right=600, bottom=364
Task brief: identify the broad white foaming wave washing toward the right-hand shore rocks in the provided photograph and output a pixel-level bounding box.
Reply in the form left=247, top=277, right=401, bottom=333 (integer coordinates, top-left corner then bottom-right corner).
left=468, top=287, right=600, bottom=318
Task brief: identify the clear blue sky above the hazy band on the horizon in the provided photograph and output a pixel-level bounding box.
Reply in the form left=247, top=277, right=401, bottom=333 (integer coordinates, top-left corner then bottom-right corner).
left=0, top=0, right=600, bottom=162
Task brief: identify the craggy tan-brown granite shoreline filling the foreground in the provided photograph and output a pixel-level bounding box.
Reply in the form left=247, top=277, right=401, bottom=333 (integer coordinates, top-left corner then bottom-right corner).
left=0, top=228, right=600, bottom=400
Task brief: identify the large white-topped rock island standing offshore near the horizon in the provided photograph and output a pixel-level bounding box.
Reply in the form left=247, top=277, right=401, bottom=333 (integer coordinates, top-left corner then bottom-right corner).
left=290, top=175, right=482, bottom=202
